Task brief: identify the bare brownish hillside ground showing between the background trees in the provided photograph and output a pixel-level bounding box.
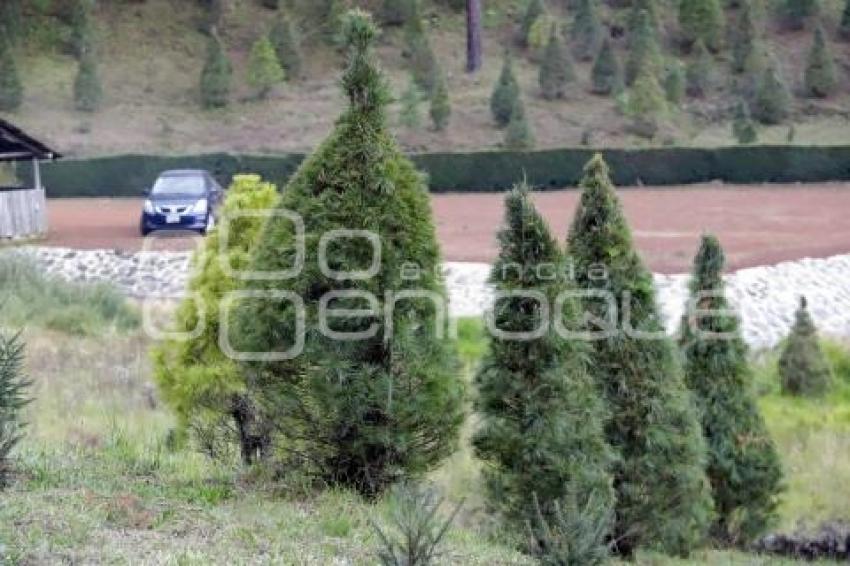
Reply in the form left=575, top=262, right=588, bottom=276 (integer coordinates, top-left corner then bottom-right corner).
left=2, top=0, right=850, bottom=156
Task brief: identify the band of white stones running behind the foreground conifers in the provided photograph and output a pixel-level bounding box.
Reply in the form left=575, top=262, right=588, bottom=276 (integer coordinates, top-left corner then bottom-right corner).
left=4, top=247, right=850, bottom=349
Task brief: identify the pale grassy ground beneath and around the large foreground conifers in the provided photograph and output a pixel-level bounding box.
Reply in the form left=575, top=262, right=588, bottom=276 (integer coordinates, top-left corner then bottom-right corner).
left=0, top=298, right=850, bottom=565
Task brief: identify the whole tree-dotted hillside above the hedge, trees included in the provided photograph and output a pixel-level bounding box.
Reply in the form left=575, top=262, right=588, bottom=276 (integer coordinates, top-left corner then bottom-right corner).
left=0, top=0, right=850, bottom=155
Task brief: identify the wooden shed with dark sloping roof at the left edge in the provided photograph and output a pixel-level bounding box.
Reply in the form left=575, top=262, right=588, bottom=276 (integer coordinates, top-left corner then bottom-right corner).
left=0, top=119, right=61, bottom=240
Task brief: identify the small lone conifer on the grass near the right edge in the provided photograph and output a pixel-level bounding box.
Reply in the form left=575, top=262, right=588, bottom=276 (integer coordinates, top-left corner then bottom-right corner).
left=779, top=297, right=832, bottom=397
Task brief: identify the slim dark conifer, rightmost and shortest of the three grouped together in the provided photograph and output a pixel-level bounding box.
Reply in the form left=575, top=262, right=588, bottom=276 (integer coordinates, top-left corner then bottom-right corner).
left=681, top=235, right=782, bottom=545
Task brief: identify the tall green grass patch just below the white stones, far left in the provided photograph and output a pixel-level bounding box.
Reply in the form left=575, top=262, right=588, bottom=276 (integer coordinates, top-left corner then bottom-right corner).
left=0, top=253, right=140, bottom=336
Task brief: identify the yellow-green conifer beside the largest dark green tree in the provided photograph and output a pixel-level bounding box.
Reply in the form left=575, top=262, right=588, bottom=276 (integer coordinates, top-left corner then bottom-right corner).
left=153, top=175, right=278, bottom=464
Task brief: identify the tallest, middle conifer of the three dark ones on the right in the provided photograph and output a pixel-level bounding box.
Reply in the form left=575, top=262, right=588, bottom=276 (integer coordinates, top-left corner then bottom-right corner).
left=567, top=155, right=711, bottom=556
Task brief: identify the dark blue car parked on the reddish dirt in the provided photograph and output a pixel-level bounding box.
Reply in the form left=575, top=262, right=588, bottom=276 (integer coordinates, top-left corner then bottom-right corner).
left=140, top=169, right=223, bottom=236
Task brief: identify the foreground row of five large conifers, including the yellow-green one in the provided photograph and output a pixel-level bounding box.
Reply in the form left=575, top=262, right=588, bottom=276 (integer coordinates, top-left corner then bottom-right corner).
left=147, top=11, right=820, bottom=564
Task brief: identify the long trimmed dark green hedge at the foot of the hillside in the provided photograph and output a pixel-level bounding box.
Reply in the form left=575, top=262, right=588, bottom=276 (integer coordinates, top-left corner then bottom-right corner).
left=16, top=146, right=850, bottom=197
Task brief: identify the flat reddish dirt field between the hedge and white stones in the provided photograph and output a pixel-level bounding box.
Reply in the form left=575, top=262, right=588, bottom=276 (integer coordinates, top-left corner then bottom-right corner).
left=41, top=183, right=850, bottom=273
